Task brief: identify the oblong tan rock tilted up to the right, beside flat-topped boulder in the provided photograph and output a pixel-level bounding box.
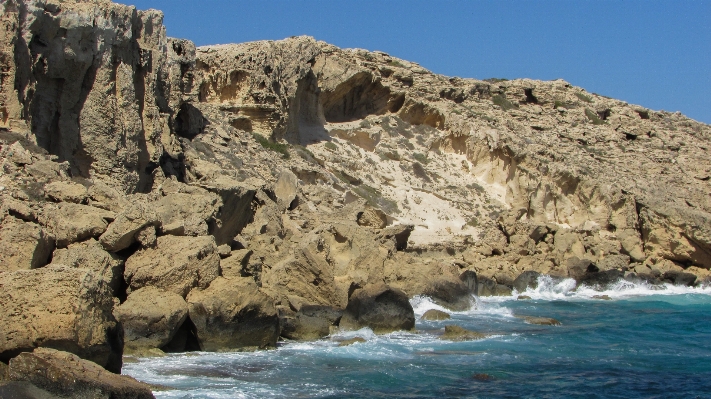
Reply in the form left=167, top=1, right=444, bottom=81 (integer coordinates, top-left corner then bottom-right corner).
left=99, top=201, right=158, bottom=252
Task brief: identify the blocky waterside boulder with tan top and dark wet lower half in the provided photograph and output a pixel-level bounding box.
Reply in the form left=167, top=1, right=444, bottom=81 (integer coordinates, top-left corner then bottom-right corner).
left=188, top=277, right=279, bottom=351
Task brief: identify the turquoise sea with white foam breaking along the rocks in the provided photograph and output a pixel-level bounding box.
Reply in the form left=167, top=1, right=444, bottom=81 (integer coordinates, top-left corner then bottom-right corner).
left=124, top=279, right=711, bottom=398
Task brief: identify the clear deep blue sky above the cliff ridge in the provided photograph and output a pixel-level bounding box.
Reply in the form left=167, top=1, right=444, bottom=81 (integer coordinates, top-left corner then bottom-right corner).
left=125, top=0, right=711, bottom=123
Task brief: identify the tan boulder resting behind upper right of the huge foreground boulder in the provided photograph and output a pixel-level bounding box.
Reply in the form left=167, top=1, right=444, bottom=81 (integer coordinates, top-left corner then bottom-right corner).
left=52, top=239, right=123, bottom=296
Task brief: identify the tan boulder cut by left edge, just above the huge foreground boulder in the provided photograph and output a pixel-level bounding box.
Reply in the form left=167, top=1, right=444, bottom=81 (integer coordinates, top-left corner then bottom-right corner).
left=0, top=216, right=54, bottom=272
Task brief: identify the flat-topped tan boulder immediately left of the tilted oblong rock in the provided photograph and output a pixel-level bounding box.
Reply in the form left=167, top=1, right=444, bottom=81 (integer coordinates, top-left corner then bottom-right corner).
left=40, top=202, right=116, bottom=248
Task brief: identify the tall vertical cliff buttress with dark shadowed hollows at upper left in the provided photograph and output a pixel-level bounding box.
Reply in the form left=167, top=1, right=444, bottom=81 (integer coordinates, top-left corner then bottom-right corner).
left=0, top=0, right=189, bottom=191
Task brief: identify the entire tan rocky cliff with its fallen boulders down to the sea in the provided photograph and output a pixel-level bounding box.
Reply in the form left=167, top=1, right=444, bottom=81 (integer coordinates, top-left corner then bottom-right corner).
left=0, top=0, right=711, bottom=384
